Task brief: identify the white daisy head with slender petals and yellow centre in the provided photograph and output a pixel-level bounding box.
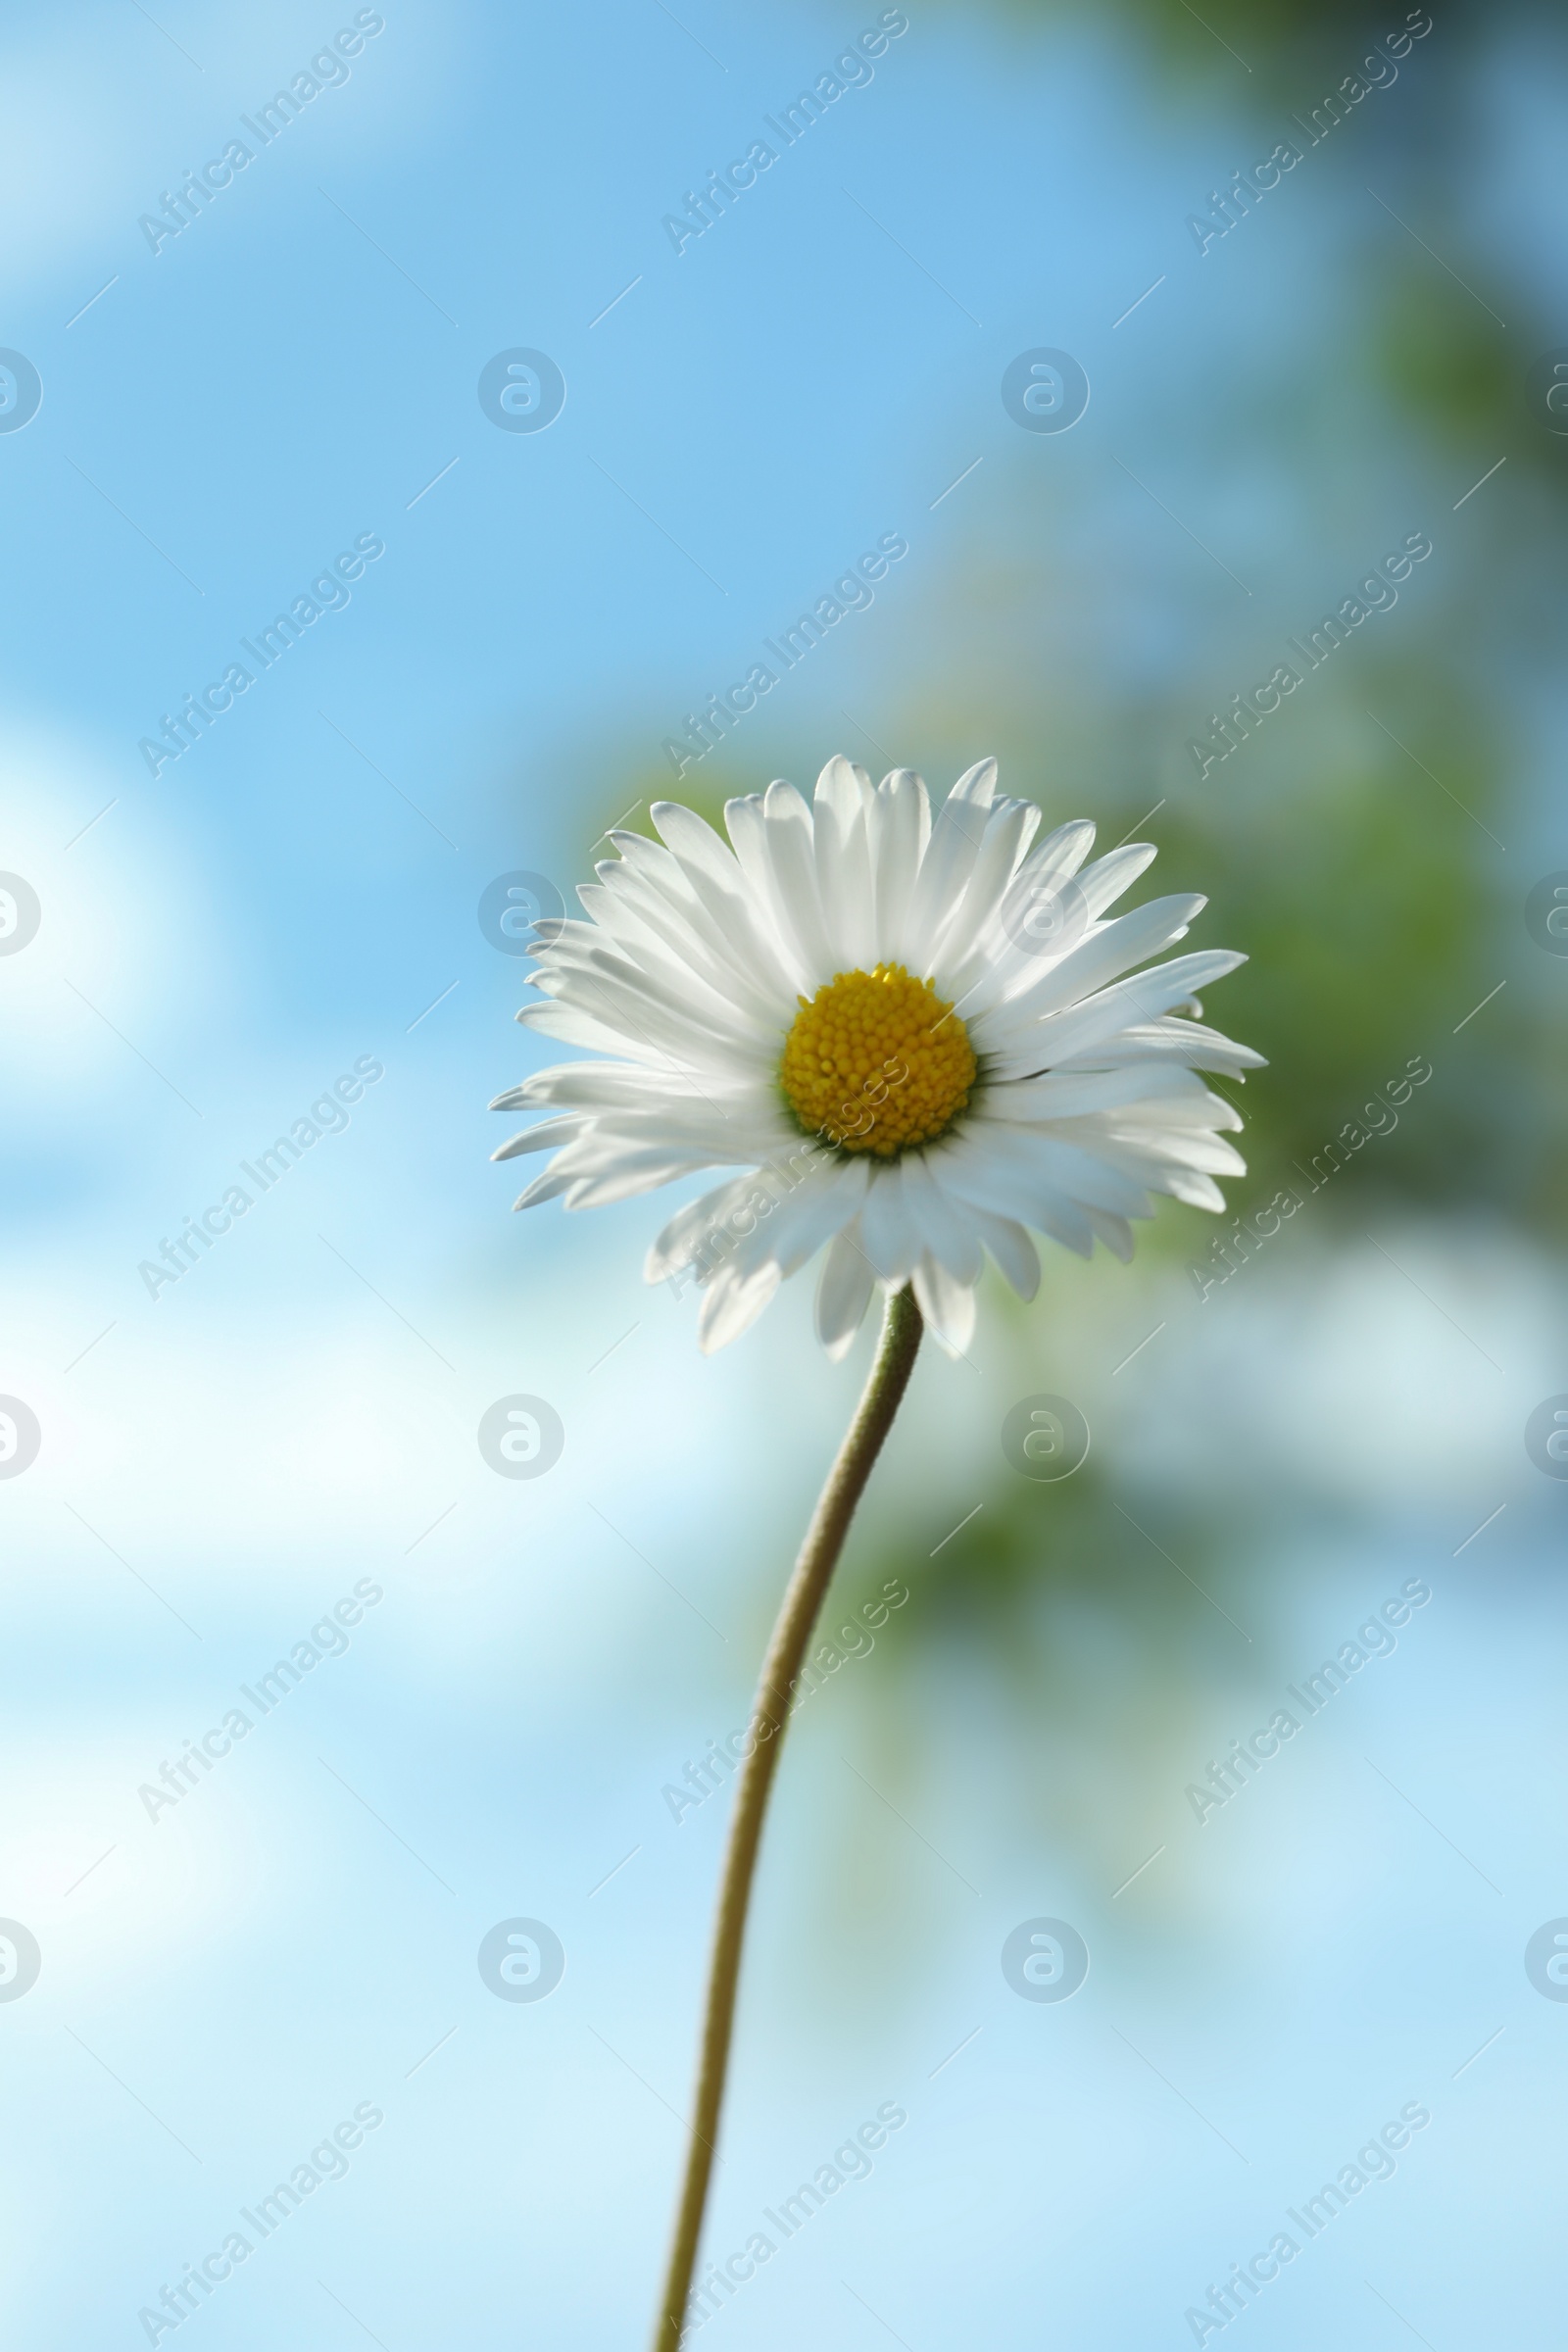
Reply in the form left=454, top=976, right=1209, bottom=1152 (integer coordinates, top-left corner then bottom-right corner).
left=491, top=758, right=1262, bottom=1354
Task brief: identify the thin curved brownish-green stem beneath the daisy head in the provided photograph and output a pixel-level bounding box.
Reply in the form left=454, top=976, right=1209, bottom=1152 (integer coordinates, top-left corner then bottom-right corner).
left=654, top=1287, right=924, bottom=2352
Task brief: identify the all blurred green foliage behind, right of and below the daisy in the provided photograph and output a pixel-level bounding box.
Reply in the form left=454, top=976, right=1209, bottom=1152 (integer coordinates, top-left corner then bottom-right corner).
left=555, top=0, right=1568, bottom=1865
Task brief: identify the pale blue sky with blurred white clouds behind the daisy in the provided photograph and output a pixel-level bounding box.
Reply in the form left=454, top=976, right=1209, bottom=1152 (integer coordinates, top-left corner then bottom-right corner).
left=0, top=0, right=1568, bottom=2352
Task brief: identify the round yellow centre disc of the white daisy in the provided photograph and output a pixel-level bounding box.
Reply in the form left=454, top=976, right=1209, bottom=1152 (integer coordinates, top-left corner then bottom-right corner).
left=778, top=964, right=976, bottom=1159
